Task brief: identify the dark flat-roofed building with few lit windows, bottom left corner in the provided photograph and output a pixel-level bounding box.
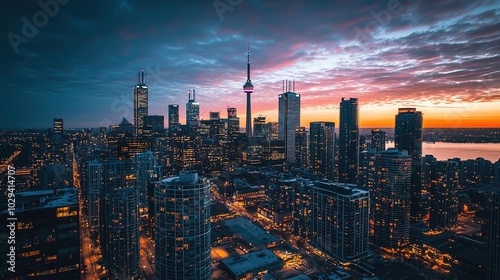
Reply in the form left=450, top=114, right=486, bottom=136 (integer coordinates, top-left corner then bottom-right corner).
left=0, top=188, right=80, bottom=280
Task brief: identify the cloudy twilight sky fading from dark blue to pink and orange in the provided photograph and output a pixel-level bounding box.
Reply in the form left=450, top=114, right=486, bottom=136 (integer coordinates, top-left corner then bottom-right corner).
left=0, top=0, right=500, bottom=128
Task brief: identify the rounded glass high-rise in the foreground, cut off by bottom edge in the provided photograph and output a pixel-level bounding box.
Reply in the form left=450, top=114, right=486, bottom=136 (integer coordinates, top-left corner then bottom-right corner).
left=155, top=171, right=212, bottom=280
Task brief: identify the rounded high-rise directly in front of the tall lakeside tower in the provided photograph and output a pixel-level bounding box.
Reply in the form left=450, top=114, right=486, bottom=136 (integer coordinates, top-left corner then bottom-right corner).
left=370, top=149, right=411, bottom=248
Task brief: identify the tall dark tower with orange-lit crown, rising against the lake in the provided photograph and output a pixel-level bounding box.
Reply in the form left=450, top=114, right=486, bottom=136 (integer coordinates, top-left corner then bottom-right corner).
left=394, top=108, right=424, bottom=222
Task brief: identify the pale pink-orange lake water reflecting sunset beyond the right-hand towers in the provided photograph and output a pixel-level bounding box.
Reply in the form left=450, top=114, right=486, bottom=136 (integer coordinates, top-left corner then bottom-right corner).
left=386, top=142, right=500, bottom=163
